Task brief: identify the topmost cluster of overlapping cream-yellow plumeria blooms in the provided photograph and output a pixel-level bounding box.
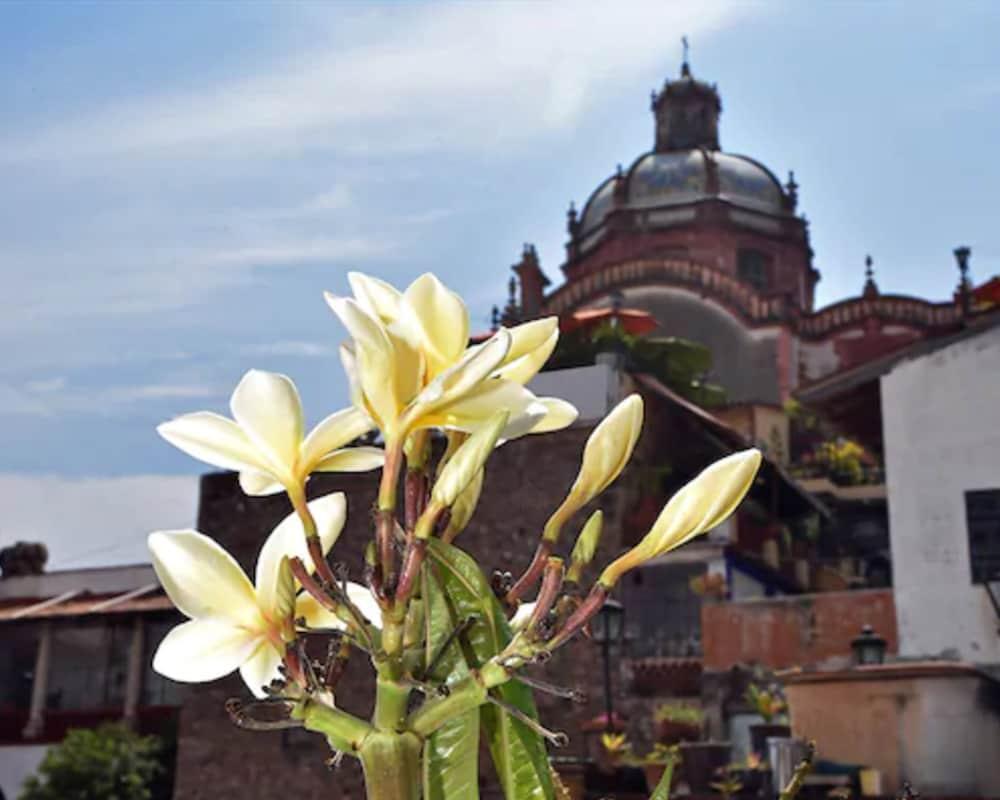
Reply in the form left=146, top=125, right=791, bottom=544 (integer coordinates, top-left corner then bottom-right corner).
left=326, top=272, right=577, bottom=441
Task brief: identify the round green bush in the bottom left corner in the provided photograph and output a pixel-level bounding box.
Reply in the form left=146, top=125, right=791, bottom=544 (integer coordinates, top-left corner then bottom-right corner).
left=19, top=723, right=163, bottom=800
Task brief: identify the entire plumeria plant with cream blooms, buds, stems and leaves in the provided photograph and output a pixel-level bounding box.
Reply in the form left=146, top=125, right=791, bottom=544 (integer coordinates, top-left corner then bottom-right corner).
left=149, top=273, right=761, bottom=800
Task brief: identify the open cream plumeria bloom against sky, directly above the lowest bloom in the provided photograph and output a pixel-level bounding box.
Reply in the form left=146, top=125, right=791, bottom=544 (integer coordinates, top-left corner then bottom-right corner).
left=157, top=370, right=383, bottom=495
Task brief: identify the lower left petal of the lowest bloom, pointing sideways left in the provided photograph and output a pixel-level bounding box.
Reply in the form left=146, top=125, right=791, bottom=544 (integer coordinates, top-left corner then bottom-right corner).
left=153, top=619, right=261, bottom=683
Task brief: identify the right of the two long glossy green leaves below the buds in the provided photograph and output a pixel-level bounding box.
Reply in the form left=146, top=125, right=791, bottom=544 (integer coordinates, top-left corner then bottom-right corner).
left=428, top=539, right=554, bottom=800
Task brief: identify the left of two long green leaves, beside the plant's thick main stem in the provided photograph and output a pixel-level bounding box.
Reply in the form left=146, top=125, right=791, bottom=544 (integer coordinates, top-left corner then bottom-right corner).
left=421, top=565, right=479, bottom=800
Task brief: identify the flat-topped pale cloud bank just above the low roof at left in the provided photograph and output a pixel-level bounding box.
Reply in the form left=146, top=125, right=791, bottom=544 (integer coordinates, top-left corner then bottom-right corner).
left=0, top=473, right=198, bottom=569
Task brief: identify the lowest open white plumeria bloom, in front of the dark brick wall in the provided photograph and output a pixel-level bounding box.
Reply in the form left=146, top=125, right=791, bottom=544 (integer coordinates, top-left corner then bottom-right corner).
left=149, top=492, right=381, bottom=697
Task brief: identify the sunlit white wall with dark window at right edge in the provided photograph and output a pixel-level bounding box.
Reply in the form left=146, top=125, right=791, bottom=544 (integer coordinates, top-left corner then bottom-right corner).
left=881, top=328, right=1000, bottom=663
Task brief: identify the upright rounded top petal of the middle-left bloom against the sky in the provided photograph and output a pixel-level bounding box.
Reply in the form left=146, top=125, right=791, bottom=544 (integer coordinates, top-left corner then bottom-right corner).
left=229, top=369, right=303, bottom=477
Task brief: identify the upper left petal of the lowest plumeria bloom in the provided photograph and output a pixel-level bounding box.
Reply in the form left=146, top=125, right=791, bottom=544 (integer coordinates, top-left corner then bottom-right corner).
left=148, top=530, right=261, bottom=629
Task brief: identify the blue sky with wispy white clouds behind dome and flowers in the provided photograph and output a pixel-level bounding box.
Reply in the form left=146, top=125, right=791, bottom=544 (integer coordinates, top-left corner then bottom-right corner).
left=0, top=0, right=1000, bottom=565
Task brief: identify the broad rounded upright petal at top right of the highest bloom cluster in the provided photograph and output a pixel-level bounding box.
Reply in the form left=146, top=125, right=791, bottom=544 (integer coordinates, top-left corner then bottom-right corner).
left=401, top=272, right=469, bottom=376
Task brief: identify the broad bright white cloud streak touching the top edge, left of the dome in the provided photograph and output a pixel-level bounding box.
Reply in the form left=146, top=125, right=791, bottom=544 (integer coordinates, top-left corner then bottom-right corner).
left=0, top=0, right=752, bottom=161
